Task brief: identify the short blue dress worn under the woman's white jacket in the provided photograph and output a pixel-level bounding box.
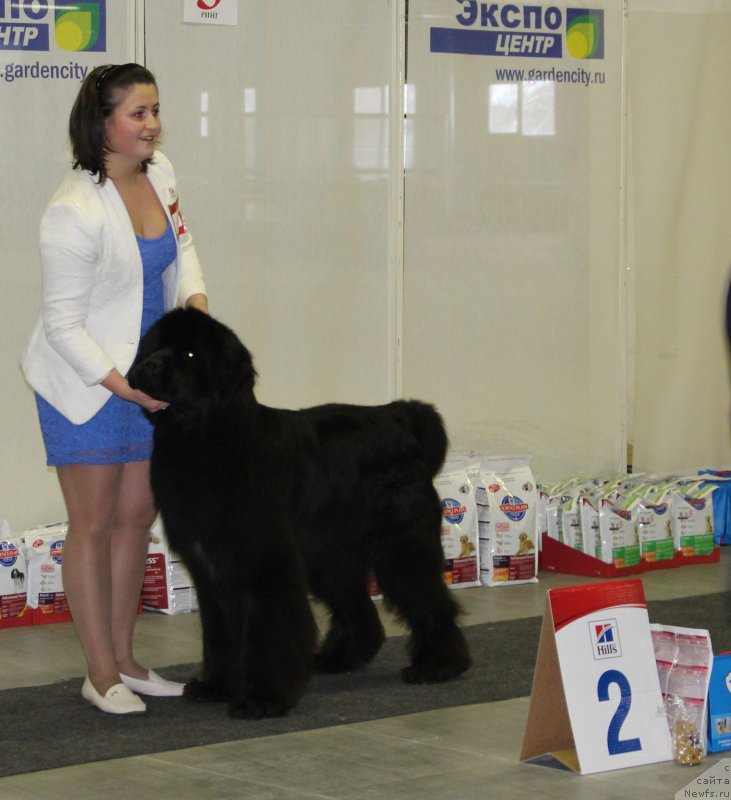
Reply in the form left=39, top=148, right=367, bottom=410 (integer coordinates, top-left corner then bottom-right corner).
left=36, top=223, right=175, bottom=467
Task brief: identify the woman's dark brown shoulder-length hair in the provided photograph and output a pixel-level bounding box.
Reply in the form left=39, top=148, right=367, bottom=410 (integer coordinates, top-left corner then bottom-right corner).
left=69, top=64, right=157, bottom=183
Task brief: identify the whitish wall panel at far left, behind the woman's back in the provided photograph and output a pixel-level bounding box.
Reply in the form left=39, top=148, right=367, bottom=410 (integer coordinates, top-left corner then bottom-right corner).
left=0, top=0, right=136, bottom=531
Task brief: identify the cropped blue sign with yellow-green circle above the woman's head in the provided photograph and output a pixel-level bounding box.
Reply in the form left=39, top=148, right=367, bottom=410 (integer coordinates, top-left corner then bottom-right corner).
left=0, top=0, right=107, bottom=53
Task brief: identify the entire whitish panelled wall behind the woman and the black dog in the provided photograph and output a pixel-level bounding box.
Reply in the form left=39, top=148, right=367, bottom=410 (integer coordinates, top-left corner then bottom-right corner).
left=0, top=0, right=731, bottom=530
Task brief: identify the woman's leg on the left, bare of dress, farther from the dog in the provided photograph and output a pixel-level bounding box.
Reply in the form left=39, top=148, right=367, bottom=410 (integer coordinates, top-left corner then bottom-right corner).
left=57, top=464, right=123, bottom=695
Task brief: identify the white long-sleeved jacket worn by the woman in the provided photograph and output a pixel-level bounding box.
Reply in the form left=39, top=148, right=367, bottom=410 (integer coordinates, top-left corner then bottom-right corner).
left=22, top=152, right=206, bottom=424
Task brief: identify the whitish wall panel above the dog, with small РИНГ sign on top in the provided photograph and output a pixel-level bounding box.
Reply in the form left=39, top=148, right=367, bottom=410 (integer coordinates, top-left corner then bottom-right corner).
left=145, top=0, right=399, bottom=407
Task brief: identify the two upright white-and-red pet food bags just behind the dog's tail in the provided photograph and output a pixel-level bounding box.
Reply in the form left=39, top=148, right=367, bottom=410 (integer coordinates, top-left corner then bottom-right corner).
left=434, top=452, right=538, bottom=586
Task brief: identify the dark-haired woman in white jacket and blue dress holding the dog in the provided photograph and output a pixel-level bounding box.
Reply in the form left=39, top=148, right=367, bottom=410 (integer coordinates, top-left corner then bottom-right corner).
left=23, top=64, right=208, bottom=714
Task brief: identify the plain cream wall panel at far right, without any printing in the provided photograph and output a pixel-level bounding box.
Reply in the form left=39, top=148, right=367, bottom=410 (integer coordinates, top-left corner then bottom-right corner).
left=628, top=0, right=731, bottom=471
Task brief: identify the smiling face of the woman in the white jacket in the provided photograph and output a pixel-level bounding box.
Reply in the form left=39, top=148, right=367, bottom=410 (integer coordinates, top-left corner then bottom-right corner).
left=105, top=83, right=161, bottom=164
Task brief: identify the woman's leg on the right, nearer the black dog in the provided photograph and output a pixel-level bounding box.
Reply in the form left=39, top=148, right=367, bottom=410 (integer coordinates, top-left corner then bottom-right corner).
left=111, top=461, right=156, bottom=680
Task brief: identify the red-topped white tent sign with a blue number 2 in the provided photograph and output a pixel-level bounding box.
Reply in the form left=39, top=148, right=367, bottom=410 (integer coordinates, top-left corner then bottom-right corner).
left=520, top=579, right=672, bottom=775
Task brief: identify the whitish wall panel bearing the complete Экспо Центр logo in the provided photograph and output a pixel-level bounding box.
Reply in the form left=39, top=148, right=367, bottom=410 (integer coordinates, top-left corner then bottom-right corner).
left=403, top=0, right=624, bottom=480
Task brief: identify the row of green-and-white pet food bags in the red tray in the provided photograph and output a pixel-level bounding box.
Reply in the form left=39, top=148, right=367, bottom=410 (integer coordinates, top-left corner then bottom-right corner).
left=538, top=475, right=717, bottom=567
